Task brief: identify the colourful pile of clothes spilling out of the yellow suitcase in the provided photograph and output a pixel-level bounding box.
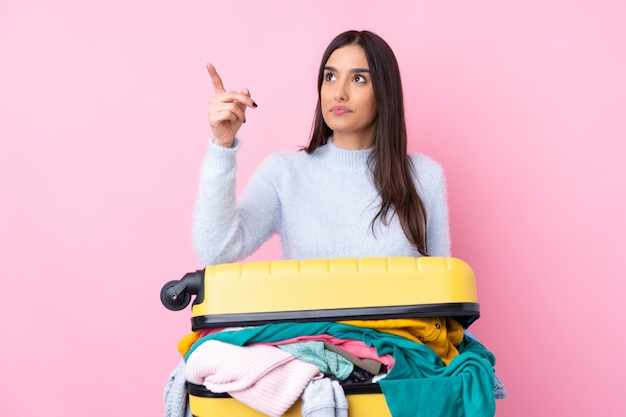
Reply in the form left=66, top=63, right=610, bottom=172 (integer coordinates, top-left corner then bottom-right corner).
left=165, top=317, right=506, bottom=417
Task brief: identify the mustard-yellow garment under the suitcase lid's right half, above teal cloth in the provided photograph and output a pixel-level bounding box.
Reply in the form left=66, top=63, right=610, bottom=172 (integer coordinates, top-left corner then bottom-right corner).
left=339, top=317, right=463, bottom=365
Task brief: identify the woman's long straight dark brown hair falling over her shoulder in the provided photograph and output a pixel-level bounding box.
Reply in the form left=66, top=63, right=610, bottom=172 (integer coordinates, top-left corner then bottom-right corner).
left=304, top=30, right=428, bottom=255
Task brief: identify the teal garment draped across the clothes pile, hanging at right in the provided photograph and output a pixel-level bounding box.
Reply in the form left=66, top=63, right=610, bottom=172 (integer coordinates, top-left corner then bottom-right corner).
left=187, top=322, right=495, bottom=417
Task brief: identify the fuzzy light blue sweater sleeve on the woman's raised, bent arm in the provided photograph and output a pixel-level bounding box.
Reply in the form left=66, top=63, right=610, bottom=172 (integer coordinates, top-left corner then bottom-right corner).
left=192, top=140, right=279, bottom=266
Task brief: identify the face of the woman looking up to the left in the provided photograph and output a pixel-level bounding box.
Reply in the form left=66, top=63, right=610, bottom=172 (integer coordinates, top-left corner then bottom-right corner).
left=320, top=45, right=377, bottom=149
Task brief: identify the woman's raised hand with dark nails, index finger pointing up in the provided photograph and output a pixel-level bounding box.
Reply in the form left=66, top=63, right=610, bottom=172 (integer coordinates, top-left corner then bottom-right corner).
left=206, top=64, right=257, bottom=148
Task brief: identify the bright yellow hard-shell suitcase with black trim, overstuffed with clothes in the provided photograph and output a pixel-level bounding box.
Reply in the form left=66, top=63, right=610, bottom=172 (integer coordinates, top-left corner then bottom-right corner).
left=161, top=257, right=480, bottom=417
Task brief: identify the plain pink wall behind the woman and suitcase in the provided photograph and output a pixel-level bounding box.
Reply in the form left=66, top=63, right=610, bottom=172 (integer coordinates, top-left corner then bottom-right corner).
left=0, top=0, right=626, bottom=417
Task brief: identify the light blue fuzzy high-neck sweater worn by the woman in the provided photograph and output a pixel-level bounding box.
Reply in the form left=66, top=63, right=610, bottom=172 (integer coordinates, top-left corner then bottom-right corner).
left=193, top=139, right=450, bottom=265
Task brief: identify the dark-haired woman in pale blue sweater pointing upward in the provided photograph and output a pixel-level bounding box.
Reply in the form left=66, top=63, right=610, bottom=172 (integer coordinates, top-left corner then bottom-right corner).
left=193, top=31, right=450, bottom=265
